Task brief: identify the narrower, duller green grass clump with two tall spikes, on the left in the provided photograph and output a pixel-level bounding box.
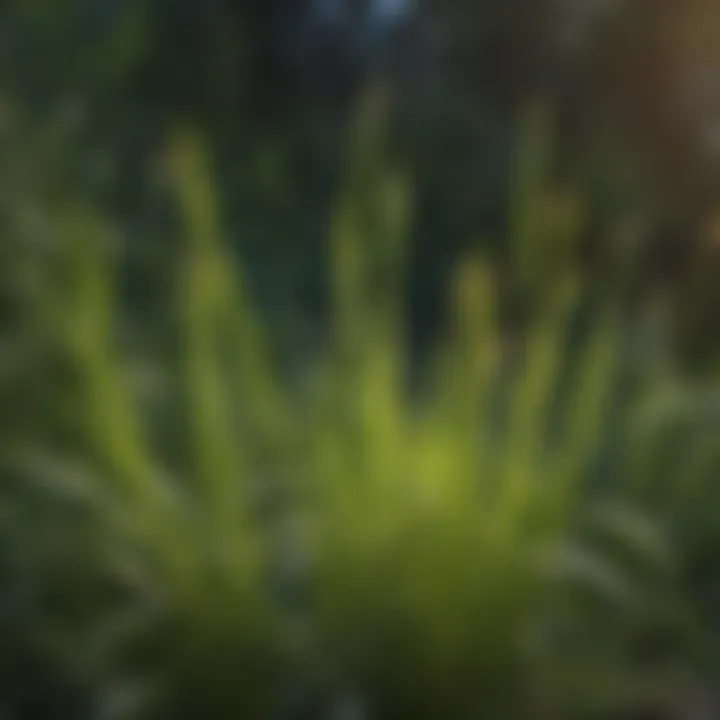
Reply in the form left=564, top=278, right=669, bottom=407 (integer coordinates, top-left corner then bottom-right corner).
left=14, top=137, right=292, bottom=718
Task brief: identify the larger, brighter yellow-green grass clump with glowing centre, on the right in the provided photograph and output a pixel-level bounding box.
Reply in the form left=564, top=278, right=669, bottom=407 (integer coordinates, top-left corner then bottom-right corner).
left=298, top=98, right=680, bottom=717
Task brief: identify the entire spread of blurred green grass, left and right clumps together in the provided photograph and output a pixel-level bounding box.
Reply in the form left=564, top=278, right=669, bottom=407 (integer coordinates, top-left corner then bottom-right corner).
left=0, top=97, right=712, bottom=719
